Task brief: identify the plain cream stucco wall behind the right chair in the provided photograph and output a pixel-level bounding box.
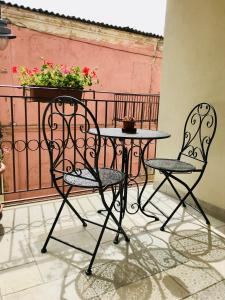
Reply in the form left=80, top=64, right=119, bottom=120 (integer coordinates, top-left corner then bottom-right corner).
left=156, top=0, right=225, bottom=213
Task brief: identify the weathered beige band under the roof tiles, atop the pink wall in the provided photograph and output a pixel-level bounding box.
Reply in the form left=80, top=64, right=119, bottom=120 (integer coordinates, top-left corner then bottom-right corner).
left=2, top=6, right=163, bottom=52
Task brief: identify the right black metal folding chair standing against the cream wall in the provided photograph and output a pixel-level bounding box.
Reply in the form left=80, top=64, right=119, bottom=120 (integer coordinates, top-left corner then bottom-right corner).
left=143, top=103, right=217, bottom=231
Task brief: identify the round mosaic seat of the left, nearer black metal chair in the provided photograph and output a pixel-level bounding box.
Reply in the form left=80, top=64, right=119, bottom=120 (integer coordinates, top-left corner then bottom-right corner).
left=64, top=168, right=124, bottom=188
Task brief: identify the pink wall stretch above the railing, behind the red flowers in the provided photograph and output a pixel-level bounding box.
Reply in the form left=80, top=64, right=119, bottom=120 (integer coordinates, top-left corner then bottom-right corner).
left=0, top=26, right=162, bottom=93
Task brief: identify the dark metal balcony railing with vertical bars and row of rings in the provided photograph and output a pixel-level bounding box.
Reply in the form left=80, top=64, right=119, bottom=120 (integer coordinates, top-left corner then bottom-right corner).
left=0, top=86, right=159, bottom=202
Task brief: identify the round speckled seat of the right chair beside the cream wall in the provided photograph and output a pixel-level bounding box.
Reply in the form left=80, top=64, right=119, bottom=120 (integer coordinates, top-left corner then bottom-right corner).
left=145, top=158, right=196, bottom=173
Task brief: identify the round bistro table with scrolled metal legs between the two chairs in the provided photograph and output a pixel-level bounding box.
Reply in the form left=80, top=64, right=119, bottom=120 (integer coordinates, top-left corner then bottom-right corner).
left=89, top=127, right=170, bottom=220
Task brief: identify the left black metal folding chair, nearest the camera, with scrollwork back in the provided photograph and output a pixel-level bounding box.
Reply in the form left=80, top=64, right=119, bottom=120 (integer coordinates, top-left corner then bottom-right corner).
left=41, top=96, right=129, bottom=275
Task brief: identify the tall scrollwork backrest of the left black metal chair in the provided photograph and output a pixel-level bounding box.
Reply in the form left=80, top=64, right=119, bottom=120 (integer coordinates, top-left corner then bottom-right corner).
left=42, top=96, right=101, bottom=182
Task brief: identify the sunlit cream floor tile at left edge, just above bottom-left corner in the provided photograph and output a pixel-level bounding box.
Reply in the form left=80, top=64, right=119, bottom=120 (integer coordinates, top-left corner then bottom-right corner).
left=0, top=263, right=43, bottom=296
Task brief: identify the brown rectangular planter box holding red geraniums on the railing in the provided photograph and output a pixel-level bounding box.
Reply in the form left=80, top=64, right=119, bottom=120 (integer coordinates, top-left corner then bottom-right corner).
left=30, top=87, right=83, bottom=102
